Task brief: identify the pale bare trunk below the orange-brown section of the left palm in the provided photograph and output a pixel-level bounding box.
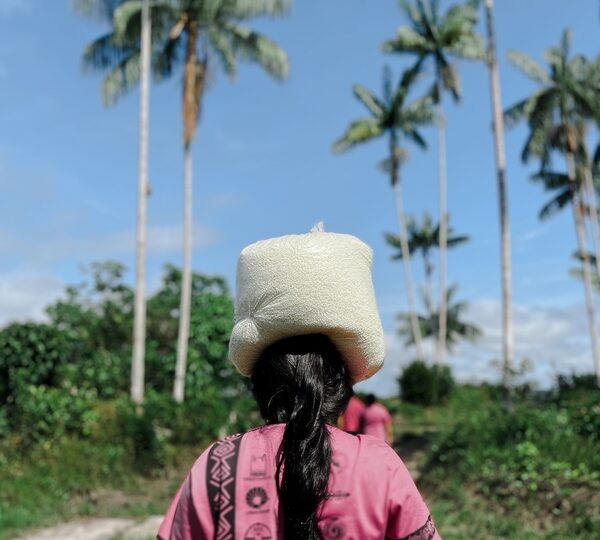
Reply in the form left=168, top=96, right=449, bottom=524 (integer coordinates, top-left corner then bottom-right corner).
left=173, top=145, right=193, bottom=403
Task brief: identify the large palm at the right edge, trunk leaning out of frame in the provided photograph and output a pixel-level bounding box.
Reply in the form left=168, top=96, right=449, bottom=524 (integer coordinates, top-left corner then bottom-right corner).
left=504, top=31, right=600, bottom=382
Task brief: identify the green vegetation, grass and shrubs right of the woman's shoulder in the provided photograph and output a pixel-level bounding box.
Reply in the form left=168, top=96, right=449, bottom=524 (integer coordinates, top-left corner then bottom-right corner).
left=389, top=376, right=600, bottom=540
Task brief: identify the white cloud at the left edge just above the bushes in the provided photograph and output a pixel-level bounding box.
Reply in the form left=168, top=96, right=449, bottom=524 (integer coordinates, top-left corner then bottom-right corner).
left=0, top=270, right=64, bottom=326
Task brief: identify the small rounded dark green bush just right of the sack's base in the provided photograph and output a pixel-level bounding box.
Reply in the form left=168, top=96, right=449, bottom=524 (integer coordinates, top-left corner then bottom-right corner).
left=398, top=360, right=454, bottom=405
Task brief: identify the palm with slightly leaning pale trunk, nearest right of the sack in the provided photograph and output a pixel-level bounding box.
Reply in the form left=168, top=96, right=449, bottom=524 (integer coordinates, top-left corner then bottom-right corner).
left=333, top=64, right=435, bottom=358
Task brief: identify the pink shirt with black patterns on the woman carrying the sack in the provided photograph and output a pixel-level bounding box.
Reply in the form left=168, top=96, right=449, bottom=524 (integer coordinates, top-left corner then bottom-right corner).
left=157, top=424, right=440, bottom=540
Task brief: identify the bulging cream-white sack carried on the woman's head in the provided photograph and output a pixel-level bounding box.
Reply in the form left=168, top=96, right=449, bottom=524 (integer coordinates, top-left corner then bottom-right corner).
left=229, top=227, right=385, bottom=382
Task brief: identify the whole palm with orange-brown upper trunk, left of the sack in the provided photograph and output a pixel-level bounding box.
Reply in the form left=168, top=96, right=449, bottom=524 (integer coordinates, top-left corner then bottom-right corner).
left=78, top=0, right=290, bottom=401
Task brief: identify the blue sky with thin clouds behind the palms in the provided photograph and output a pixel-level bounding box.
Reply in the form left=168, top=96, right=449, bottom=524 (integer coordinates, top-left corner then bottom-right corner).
left=0, top=0, right=600, bottom=393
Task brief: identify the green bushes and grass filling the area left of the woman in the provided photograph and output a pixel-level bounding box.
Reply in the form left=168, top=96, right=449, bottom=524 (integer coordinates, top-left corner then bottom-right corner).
left=0, top=262, right=257, bottom=539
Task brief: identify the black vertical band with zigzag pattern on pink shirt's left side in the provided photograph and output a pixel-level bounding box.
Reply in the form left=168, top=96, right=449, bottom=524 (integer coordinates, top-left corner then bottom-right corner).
left=206, top=435, right=242, bottom=540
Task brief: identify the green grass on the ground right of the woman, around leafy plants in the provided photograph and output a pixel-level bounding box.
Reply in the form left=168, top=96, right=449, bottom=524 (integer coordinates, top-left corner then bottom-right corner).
left=386, top=387, right=600, bottom=540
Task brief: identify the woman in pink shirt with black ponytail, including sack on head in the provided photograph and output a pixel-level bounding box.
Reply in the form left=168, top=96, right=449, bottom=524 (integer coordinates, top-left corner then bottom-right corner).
left=158, top=228, right=439, bottom=540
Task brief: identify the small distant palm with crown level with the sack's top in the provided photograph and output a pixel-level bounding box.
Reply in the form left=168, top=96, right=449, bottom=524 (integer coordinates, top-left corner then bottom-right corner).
left=385, top=213, right=469, bottom=318
